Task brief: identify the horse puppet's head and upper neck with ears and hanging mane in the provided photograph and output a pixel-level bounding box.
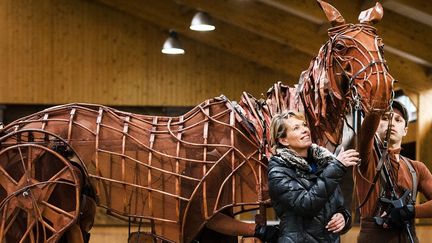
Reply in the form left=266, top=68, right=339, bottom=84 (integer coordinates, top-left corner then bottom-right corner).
left=298, top=0, right=394, bottom=147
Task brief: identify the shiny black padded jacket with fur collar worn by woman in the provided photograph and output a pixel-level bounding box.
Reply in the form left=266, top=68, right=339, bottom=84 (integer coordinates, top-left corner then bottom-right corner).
left=268, top=144, right=351, bottom=243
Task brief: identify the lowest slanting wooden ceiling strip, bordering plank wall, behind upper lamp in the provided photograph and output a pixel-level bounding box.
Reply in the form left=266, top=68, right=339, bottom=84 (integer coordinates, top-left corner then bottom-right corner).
left=93, top=0, right=312, bottom=79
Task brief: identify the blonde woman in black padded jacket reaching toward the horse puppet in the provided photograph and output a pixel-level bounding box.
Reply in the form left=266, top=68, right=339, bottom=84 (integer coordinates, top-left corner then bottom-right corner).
left=268, top=111, right=359, bottom=243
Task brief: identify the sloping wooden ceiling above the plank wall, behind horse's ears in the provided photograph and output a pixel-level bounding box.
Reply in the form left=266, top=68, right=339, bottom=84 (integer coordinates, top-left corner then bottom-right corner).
left=94, top=0, right=432, bottom=91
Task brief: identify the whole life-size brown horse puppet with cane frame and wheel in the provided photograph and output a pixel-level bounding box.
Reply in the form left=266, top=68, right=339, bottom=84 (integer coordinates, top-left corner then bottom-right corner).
left=0, top=1, right=393, bottom=243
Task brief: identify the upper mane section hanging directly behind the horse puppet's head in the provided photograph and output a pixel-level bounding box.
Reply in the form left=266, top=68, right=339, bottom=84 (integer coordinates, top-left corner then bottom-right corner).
left=297, top=40, right=349, bottom=149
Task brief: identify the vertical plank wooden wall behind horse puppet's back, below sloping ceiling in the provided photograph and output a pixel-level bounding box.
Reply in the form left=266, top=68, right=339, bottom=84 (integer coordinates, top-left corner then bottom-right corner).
left=0, top=0, right=294, bottom=106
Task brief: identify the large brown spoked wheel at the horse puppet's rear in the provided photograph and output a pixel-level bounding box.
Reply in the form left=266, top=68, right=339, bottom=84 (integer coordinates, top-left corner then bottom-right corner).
left=0, top=143, right=80, bottom=243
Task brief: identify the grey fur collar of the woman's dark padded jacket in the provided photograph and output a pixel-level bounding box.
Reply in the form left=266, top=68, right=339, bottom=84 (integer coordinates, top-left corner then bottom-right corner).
left=276, top=143, right=336, bottom=171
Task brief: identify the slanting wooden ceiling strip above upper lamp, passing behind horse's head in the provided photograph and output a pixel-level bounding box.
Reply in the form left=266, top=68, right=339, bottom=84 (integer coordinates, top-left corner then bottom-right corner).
left=181, top=0, right=432, bottom=89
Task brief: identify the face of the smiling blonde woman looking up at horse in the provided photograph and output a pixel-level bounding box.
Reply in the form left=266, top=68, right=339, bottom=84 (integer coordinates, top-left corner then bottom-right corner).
left=279, top=117, right=312, bottom=153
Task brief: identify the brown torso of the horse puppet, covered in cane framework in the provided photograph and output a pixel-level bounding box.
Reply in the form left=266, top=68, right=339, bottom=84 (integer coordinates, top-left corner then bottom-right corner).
left=2, top=97, right=267, bottom=242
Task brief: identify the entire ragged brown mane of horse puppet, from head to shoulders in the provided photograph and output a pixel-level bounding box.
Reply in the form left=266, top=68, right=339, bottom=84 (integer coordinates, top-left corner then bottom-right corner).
left=237, top=41, right=349, bottom=158
